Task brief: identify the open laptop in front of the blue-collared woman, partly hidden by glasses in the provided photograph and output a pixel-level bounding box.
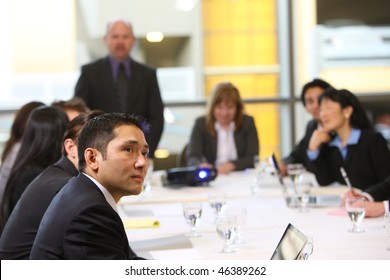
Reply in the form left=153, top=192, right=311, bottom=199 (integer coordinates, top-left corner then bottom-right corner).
left=271, top=154, right=342, bottom=207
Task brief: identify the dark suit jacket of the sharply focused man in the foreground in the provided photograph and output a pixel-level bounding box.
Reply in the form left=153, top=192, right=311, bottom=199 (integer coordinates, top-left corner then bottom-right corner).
left=30, top=173, right=138, bottom=260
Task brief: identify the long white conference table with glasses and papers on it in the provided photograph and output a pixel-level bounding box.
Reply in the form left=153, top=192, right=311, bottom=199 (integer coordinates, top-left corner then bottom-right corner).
left=118, top=169, right=390, bottom=260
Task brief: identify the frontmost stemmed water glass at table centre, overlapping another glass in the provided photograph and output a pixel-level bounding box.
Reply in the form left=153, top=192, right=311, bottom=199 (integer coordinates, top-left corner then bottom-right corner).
left=216, top=215, right=238, bottom=253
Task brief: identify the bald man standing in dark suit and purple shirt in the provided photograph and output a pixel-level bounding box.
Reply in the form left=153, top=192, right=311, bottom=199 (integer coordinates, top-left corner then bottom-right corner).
left=75, top=20, right=164, bottom=158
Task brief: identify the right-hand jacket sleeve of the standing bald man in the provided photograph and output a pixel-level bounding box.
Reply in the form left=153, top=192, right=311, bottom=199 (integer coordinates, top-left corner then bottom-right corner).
left=146, top=70, right=164, bottom=157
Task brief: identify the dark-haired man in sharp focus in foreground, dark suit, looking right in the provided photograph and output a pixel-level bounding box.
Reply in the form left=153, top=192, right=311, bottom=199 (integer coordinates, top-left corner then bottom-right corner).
left=30, top=113, right=149, bottom=260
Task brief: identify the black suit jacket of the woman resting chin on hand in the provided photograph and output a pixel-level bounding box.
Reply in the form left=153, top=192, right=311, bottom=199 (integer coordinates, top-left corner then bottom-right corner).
left=310, top=130, right=390, bottom=195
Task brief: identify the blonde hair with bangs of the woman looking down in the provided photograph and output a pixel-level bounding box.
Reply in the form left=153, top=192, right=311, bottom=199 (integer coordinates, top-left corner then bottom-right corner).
left=206, top=82, right=244, bottom=136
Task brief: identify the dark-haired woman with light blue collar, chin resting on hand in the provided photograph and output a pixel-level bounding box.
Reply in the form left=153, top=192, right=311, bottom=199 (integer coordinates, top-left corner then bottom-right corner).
left=307, top=89, right=390, bottom=190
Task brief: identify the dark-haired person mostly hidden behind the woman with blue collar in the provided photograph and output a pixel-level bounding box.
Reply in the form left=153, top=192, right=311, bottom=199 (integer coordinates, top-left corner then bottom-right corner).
left=279, top=79, right=331, bottom=176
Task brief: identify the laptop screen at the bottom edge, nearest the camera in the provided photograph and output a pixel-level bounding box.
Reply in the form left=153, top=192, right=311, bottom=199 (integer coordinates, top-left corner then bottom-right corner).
left=271, top=223, right=307, bottom=260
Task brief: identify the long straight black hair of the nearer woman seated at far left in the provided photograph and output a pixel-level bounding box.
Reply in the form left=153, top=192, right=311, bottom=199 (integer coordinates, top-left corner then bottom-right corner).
left=0, top=106, right=69, bottom=230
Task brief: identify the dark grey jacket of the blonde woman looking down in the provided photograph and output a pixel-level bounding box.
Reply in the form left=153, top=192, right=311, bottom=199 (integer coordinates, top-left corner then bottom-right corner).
left=187, top=115, right=259, bottom=170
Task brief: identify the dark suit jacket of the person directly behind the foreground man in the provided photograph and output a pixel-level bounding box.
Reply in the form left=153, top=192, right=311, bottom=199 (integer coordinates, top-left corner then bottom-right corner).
left=0, top=156, right=78, bottom=260
